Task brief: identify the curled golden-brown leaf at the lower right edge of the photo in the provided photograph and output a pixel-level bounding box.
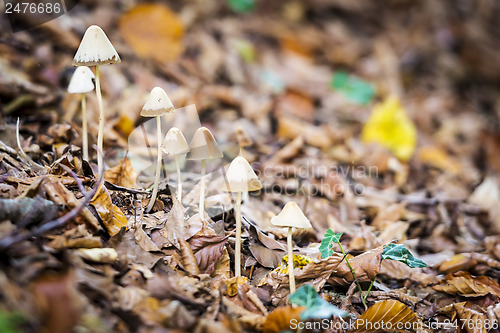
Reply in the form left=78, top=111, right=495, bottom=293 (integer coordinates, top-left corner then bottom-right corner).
left=432, top=272, right=500, bottom=297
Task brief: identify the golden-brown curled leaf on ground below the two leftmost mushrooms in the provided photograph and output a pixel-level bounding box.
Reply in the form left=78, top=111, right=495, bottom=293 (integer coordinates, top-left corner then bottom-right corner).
left=90, top=186, right=127, bottom=236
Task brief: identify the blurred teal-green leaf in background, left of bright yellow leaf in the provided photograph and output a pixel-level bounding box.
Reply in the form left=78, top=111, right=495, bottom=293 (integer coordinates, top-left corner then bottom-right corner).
left=330, top=71, right=375, bottom=105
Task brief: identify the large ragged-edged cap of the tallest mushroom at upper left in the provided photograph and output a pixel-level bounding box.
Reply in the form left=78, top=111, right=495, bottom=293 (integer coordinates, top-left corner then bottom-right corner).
left=73, top=25, right=121, bottom=66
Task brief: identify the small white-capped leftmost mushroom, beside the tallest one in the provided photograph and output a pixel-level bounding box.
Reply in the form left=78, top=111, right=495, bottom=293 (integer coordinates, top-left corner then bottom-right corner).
left=68, top=66, right=95, bottom=161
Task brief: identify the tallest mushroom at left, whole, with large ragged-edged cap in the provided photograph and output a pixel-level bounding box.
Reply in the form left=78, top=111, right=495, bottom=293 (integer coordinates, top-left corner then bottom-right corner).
left=73, top=25, right=121, bottom=174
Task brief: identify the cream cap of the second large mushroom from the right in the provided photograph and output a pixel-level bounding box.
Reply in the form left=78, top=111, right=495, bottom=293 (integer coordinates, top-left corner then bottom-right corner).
left=223, top=156, right=262, bottom=192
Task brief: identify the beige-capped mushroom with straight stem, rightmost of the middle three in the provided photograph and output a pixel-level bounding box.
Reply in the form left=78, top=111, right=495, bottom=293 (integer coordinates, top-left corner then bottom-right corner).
left=187, top=127, right=222, bottom=221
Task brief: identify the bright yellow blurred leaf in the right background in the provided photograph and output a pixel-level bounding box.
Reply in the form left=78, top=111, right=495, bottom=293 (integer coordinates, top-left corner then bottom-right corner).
left=361, top=96, right=417, bottom=161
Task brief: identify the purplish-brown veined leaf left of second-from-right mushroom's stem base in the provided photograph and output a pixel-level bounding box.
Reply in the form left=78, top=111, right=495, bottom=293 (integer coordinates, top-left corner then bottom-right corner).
left=189, top=235, right=229, bottom=274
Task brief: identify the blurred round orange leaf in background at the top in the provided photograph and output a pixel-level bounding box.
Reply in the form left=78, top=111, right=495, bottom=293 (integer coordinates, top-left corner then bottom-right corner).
left=119, top=4, right=184, bottom=63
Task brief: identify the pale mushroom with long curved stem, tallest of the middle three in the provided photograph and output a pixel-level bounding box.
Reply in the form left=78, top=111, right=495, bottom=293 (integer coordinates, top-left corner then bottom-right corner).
left=141, top=87, right=175, bottom=212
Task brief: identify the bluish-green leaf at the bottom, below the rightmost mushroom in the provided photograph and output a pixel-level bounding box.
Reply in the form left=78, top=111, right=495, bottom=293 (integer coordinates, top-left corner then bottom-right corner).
left=288, top=284, right=348, bottom=320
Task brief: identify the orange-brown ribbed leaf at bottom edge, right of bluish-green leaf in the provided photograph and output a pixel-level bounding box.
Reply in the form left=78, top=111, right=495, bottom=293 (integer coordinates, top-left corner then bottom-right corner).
left=351, top=300, right=418, bottom=333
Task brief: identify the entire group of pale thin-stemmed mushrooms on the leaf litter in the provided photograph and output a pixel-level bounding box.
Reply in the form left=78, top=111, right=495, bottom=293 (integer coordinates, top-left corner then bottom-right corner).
left=68, top=25, right=311, bottom=293
